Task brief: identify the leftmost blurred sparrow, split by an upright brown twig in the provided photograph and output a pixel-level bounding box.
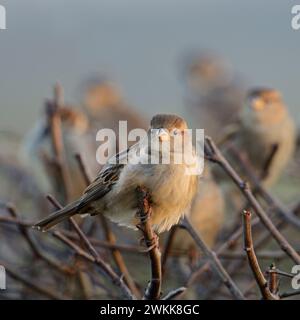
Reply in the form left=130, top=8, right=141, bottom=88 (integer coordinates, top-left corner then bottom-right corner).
left=20, top=106, right=97, bottom=199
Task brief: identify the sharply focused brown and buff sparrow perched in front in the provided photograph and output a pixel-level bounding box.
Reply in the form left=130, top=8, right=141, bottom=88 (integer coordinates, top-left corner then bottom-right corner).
left=36, top=114, right=198, bottom=233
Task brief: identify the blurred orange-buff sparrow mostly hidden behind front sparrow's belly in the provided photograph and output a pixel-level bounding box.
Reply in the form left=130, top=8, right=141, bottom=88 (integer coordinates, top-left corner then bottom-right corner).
left=169, top=164, right=225, bottom=252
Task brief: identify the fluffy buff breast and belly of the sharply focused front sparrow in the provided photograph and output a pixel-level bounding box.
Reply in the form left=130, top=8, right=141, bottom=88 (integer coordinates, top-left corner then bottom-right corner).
left=104, top=164, right=197, bottom=232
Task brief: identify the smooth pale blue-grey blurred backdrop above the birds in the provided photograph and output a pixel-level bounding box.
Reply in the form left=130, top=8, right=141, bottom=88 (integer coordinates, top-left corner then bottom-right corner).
left=0, top=0, right=300, bottom=133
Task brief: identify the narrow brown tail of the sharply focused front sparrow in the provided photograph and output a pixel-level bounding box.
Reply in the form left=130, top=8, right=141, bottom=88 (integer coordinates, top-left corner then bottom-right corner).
left=33, top=201, right=80, bottom=231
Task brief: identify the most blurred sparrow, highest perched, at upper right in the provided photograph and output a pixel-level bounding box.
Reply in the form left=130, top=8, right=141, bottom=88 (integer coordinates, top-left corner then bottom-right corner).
left=186, top=54, right=245, bottom=142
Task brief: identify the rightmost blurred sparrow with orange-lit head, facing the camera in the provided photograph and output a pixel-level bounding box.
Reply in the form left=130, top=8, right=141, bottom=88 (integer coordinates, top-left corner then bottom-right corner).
left=236, top=88, right=296, bottom=186
